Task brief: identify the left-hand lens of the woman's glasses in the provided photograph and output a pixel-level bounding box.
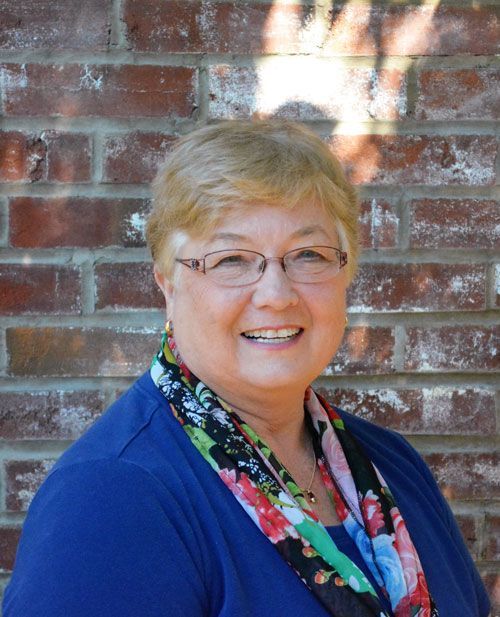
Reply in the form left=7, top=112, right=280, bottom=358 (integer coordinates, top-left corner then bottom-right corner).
left=205, top=250, right=263, bottom=287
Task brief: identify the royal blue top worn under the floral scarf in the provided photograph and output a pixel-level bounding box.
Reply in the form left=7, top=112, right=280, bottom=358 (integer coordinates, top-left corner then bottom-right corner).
left=3, top=373, right=489, bottom=617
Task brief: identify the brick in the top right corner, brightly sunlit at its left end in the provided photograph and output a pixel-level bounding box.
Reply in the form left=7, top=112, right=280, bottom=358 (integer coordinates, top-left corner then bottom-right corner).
left=322, top=3, right=499, bottom=57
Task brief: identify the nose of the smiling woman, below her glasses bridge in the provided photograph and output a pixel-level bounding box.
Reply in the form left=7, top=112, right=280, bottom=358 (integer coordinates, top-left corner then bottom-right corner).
left=252, top=259, right=299, bottom=311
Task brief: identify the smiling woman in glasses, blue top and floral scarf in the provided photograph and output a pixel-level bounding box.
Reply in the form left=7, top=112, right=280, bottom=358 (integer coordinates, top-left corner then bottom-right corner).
left=5, top=121, right=489, bottom=617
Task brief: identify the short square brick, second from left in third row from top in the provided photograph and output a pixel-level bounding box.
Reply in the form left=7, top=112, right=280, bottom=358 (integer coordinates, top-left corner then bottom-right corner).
left=44, top=131, right=92, bottom=182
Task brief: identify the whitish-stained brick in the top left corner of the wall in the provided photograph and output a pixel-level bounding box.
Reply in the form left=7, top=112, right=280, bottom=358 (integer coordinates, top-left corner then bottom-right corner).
left=0, top=0, right=111, bottom=51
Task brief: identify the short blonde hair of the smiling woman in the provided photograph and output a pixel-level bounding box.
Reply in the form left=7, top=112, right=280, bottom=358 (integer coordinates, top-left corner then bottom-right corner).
left=146, top=120, right=358, bottom=281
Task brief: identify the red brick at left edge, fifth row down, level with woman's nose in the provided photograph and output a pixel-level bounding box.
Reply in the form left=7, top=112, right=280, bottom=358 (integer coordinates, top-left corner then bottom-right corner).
left=0, top=264, right=81, bottom=315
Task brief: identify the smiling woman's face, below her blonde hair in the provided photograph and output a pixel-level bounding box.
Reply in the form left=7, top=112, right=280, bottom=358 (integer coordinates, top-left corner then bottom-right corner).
left=155, top=204, right=346, bottom=406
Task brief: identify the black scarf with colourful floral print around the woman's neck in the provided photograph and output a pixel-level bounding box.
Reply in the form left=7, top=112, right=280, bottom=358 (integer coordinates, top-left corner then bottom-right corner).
left=151, top=333, right=438, bottom=617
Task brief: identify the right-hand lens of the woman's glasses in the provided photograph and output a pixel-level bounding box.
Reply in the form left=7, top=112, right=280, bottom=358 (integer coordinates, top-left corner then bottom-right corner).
left=284, top=246, right=341, bottom=283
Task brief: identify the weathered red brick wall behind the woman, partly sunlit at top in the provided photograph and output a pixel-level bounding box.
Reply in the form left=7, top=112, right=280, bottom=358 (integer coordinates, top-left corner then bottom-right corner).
left=0, top=0, right=500, bottom=614
